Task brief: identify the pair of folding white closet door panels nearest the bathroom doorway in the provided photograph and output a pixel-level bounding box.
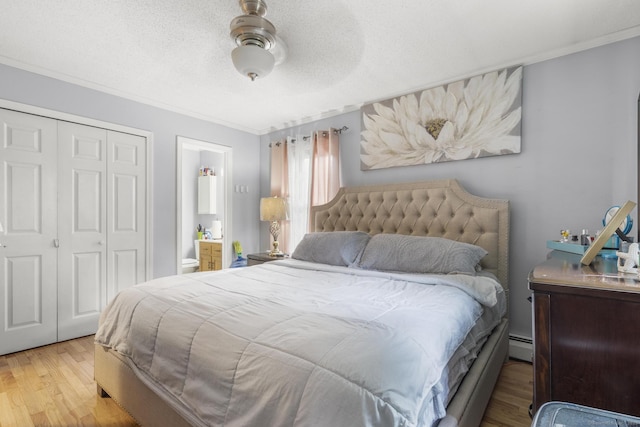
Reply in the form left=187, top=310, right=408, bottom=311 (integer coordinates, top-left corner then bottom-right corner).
left=58, top=122, right=146, bottom=341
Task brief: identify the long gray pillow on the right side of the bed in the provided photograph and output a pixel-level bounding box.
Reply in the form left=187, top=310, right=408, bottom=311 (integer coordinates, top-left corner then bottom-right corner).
left=359, top=234, right=487, bottom=274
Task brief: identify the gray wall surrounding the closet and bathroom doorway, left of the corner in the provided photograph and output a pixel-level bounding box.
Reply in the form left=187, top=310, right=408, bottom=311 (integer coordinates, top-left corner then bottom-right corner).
left=0, top=64, right=260, bottom=277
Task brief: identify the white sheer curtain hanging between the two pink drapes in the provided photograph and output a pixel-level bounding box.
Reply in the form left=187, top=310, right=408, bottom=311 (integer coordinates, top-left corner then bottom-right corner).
left=287, top=135, right=313, bottom=251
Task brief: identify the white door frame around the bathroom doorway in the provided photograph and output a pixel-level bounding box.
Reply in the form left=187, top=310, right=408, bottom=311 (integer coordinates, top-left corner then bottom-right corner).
left=176, top=135, right=233, bottom=274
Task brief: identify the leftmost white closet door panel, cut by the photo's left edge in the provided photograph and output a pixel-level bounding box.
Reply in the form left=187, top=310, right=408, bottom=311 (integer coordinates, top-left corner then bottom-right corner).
left=0, top=109, right=57, bottom=354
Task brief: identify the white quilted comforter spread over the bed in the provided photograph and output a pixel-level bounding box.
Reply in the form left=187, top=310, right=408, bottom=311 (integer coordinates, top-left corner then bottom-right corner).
left=96, top=260, right=502, bottom=427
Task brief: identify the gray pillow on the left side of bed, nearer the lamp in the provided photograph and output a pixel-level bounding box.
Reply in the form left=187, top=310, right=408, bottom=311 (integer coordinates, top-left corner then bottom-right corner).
left=291, top=231, right=371, bottom=266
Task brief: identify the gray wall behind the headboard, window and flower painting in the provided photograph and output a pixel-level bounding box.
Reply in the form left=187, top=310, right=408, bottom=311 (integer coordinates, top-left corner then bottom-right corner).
left=260, top=38, right=640, bottom=337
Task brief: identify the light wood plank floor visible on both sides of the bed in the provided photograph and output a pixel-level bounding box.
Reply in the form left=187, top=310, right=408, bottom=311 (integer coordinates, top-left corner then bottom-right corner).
left=0, top=336, right=533, bottom=427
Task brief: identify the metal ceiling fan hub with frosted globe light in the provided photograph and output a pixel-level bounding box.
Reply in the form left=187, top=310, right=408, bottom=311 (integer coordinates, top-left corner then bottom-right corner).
left=230, top=0, right=286, bottom=81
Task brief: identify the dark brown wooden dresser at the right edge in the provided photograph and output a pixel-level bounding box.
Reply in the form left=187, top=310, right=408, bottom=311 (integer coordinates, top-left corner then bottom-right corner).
left=529, top=251, right=640, bottom=416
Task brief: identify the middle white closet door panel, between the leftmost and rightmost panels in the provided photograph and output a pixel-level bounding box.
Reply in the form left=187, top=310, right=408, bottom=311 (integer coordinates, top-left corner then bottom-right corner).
left=58, top=122, right=107, bottom=340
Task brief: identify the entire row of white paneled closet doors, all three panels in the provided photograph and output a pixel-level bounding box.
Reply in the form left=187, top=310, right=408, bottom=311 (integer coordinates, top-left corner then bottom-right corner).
left=0, top=110, right=146, bottom=354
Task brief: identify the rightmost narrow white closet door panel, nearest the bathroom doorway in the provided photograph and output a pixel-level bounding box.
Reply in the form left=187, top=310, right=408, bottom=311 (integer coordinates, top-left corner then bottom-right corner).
left=107, top=131, right=147, bottom=301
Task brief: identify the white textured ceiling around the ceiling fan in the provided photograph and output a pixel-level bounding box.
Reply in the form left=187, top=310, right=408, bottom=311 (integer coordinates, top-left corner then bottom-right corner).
left=0, top=0, right=640, bottom=134
